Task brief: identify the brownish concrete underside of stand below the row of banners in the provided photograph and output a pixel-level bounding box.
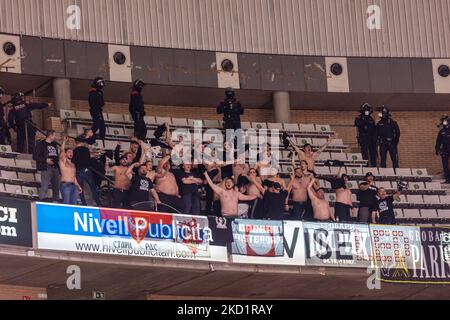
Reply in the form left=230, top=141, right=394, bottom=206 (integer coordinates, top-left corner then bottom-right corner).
left=0, top=249, right=450, bottom=300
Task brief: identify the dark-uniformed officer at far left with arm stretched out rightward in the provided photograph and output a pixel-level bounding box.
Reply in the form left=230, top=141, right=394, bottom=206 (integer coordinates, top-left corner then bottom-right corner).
left=8, top=92, right=48, bottom=154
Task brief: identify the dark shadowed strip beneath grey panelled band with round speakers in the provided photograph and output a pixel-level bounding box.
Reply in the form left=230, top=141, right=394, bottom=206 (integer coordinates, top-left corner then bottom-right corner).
left=0, top=73, right=450, bottom=111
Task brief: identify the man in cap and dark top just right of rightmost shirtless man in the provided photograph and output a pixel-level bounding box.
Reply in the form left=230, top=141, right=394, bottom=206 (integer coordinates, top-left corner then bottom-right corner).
left=356, top=172, right=378, bottom=223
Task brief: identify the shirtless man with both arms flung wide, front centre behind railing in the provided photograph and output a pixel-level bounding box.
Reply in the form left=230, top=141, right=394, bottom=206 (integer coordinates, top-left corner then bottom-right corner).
left=205, top=172, right=258, bottom=217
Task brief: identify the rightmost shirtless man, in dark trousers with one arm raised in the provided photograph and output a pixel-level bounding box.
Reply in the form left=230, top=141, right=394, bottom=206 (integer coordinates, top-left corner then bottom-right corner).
left=334, top=168, right=353, bottom=222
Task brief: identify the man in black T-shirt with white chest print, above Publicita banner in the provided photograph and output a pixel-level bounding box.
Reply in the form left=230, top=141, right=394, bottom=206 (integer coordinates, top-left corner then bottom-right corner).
left=126, top=162, right=161, bottom=210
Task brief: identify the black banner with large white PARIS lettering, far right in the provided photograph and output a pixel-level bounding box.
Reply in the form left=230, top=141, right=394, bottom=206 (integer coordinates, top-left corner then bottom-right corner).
left=380, top=227, right=450, bottom=284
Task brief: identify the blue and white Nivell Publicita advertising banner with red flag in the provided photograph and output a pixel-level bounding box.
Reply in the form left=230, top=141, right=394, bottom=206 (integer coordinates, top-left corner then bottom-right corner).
left=36, top=203, right=227, bottom=262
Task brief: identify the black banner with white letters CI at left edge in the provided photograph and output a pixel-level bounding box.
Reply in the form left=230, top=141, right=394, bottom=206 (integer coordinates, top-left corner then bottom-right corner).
left=0, top=198, right=33, bottom=247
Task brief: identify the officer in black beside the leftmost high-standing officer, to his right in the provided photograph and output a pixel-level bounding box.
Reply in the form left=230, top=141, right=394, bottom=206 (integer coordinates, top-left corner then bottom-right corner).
left=130, top=80, right=147, bottom=141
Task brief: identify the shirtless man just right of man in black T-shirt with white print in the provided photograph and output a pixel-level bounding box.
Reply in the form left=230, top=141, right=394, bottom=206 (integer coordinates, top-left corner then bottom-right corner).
left=155, top=155, right=184, bottom=212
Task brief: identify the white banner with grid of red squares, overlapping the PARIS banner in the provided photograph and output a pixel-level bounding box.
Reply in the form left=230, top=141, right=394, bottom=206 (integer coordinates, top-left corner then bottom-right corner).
left=370, top=225, right=422, bottom=279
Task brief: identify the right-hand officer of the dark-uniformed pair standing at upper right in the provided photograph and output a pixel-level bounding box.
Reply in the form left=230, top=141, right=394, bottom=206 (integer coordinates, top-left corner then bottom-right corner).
left=376, top=106, right=400, bottom=169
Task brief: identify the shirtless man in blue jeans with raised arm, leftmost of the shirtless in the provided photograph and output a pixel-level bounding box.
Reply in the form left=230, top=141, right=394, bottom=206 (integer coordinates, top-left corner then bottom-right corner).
left=59, top=137, right=83, bottom=205
